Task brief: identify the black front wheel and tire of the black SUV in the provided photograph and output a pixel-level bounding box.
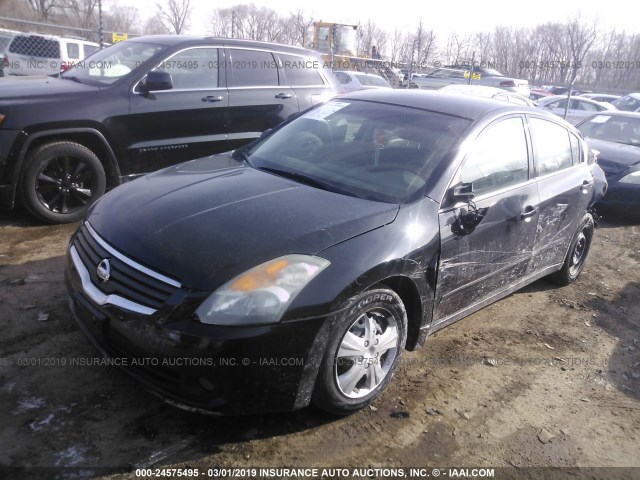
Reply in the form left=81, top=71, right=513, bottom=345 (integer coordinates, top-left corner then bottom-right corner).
left=21, top=142, right=106, bottom=223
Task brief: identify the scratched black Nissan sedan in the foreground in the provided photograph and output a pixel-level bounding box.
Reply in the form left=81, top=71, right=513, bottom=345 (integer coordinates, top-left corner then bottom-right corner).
left=65, top=90, right=598, bottom=414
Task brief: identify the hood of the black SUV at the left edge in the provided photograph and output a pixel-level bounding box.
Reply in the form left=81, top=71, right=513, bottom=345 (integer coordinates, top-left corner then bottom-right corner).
left=0, top=75, right=99, bottom=102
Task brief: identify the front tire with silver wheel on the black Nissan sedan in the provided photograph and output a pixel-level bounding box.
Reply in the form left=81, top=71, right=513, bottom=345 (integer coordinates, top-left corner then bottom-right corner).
left=312, top=289, right=407, bottom=415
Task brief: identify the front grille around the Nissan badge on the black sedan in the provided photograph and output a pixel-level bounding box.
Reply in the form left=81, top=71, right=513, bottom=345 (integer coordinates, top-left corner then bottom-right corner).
left=73, top=223, right=180, bottom=310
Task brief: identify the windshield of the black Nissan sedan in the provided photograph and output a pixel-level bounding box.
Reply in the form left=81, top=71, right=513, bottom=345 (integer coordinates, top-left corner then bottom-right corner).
left=242, top=100, right=470, bottom=203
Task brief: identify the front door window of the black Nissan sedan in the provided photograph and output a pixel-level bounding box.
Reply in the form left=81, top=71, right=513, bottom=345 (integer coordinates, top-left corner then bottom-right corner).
left=459, top=117, right=529, bottom=195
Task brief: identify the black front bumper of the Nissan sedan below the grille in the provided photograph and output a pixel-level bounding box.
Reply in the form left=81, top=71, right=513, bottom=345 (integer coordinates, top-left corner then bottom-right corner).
left=65, top=251, right=327, bottom=415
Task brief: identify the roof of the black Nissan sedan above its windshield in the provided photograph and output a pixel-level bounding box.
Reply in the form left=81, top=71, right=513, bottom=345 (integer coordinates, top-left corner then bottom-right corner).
left=336, top=89, right=536, bottom=120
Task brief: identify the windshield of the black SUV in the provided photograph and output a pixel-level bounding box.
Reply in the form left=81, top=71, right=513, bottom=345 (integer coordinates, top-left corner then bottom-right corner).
left=60, top=42, right=168, bottom=86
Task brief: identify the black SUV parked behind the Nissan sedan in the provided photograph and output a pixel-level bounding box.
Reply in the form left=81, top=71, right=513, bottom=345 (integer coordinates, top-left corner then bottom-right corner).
left=0, top=36, right=340, bottom=223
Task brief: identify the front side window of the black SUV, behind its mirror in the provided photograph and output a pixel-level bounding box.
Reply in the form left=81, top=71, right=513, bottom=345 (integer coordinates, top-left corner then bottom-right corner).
left=155, top=48, right=218, bottom=90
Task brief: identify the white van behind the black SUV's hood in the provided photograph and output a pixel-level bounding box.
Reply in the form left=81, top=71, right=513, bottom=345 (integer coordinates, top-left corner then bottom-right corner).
left=4, top=33, right=100, bottom=75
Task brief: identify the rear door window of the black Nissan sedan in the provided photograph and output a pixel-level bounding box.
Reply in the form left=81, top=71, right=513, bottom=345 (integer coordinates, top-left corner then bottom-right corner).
left=530, top=118, right=573, bottom=176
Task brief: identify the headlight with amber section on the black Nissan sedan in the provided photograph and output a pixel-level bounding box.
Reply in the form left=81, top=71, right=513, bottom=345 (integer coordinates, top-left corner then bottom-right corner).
left=196, top=255, right=330, bottom=325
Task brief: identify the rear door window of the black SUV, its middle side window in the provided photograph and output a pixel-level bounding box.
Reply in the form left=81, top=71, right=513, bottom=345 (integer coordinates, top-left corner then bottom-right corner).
left=229, top=48, right=278, bottom=87
